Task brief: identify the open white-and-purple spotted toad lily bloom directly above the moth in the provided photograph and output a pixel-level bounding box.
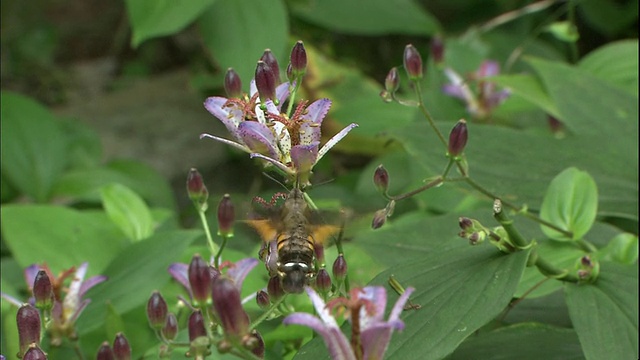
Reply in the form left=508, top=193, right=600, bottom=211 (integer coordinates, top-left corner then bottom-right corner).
left=200, top=73, right=358, bottom=184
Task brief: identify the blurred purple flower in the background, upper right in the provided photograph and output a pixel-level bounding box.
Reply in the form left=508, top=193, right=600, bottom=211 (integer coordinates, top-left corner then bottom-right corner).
left=442, top=60, right=511, bottom=119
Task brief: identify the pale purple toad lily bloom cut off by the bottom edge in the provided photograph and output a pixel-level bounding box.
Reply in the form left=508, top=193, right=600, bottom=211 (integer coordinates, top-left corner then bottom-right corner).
left=283, top=286, right=414, bottom=360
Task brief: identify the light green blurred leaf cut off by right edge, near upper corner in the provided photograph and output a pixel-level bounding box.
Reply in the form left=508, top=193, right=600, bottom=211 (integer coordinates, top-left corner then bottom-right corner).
left=578, top=40, right=638, bottom=96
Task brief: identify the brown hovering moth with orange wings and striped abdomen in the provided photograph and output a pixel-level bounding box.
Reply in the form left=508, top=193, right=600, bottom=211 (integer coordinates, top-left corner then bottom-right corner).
left=247, top=187, right=340, bottom=294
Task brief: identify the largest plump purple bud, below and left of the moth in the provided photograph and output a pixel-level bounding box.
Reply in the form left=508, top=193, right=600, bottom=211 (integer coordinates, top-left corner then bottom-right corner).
left=211, top=276, right=249, bottom=339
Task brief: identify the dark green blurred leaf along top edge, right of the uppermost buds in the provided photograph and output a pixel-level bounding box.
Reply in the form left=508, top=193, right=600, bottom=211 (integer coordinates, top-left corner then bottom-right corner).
left=292, top=0, right=440, bottom=35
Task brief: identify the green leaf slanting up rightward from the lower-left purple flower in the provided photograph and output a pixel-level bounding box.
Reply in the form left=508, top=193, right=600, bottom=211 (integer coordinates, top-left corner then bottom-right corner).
left=78, top=231, right=201, bottom=334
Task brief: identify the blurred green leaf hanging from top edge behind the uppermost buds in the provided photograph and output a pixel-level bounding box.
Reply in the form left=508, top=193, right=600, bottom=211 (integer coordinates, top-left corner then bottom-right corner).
left=198, top=0, right=291, bottom=84
